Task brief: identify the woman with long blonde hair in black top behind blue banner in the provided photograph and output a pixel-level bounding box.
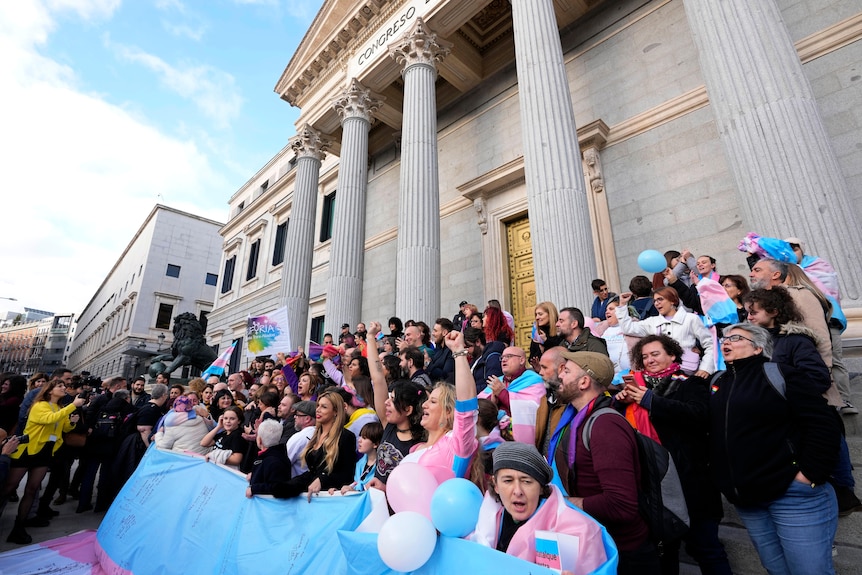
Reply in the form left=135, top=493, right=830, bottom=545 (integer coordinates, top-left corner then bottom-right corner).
left=272, top=390, right=356, bottom=501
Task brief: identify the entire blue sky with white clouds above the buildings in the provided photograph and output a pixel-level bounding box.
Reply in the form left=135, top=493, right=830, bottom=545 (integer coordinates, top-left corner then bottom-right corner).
left=0, top=0, right=322, bottom=314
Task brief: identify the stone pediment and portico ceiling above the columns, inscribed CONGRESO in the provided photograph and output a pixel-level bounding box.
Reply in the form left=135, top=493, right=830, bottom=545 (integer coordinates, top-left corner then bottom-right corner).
left=275, top=0, right=602, bottom=134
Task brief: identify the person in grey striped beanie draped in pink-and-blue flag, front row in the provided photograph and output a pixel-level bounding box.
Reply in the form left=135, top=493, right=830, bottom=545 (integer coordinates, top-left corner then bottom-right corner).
left=470, top=441, right=616, bottom=573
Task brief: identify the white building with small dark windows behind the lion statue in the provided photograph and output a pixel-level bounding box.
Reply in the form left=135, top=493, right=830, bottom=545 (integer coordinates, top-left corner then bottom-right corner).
left=68, top=205, right=222, bottom=377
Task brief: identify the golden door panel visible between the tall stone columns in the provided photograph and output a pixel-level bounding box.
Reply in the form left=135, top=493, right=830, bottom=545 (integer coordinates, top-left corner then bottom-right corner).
left=506, top=217, right=536, bottom=350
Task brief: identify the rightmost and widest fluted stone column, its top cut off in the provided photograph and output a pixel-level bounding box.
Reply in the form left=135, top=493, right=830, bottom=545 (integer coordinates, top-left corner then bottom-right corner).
left=684, top=0, right=862, bottom=300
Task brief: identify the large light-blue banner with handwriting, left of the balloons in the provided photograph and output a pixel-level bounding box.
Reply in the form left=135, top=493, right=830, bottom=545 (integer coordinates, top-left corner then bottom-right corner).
left=97, top=449, right=371, bottom=575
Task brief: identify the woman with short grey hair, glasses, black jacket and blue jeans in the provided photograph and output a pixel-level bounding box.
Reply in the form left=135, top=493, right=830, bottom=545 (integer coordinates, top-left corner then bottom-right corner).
left=709, top=324, right=841, bottom=574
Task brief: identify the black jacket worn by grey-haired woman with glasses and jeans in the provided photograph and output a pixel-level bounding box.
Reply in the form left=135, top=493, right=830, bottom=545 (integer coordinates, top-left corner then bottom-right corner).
left=709, top=355, right=841, bottom=505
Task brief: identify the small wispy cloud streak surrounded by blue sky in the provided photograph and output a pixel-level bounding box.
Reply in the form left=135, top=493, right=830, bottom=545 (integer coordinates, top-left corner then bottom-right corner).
left=105, top=38, right=243, bottom=128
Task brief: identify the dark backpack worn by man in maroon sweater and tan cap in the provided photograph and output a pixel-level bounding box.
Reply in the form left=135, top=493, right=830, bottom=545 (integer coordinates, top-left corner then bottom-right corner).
left=581, top=407, right=689, bottom=544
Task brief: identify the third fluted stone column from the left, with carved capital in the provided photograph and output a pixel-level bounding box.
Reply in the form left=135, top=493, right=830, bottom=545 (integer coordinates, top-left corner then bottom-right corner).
left=389, top=18, right=452, bottom=324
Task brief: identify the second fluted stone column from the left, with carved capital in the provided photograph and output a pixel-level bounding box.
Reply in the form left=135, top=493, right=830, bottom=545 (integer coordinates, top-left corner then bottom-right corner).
left=326, top=78, right=382, bottom=327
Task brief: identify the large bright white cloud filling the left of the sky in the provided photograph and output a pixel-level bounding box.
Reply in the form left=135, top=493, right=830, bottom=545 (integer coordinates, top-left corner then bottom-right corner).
left=0, top=0, right=233, bottom=313
